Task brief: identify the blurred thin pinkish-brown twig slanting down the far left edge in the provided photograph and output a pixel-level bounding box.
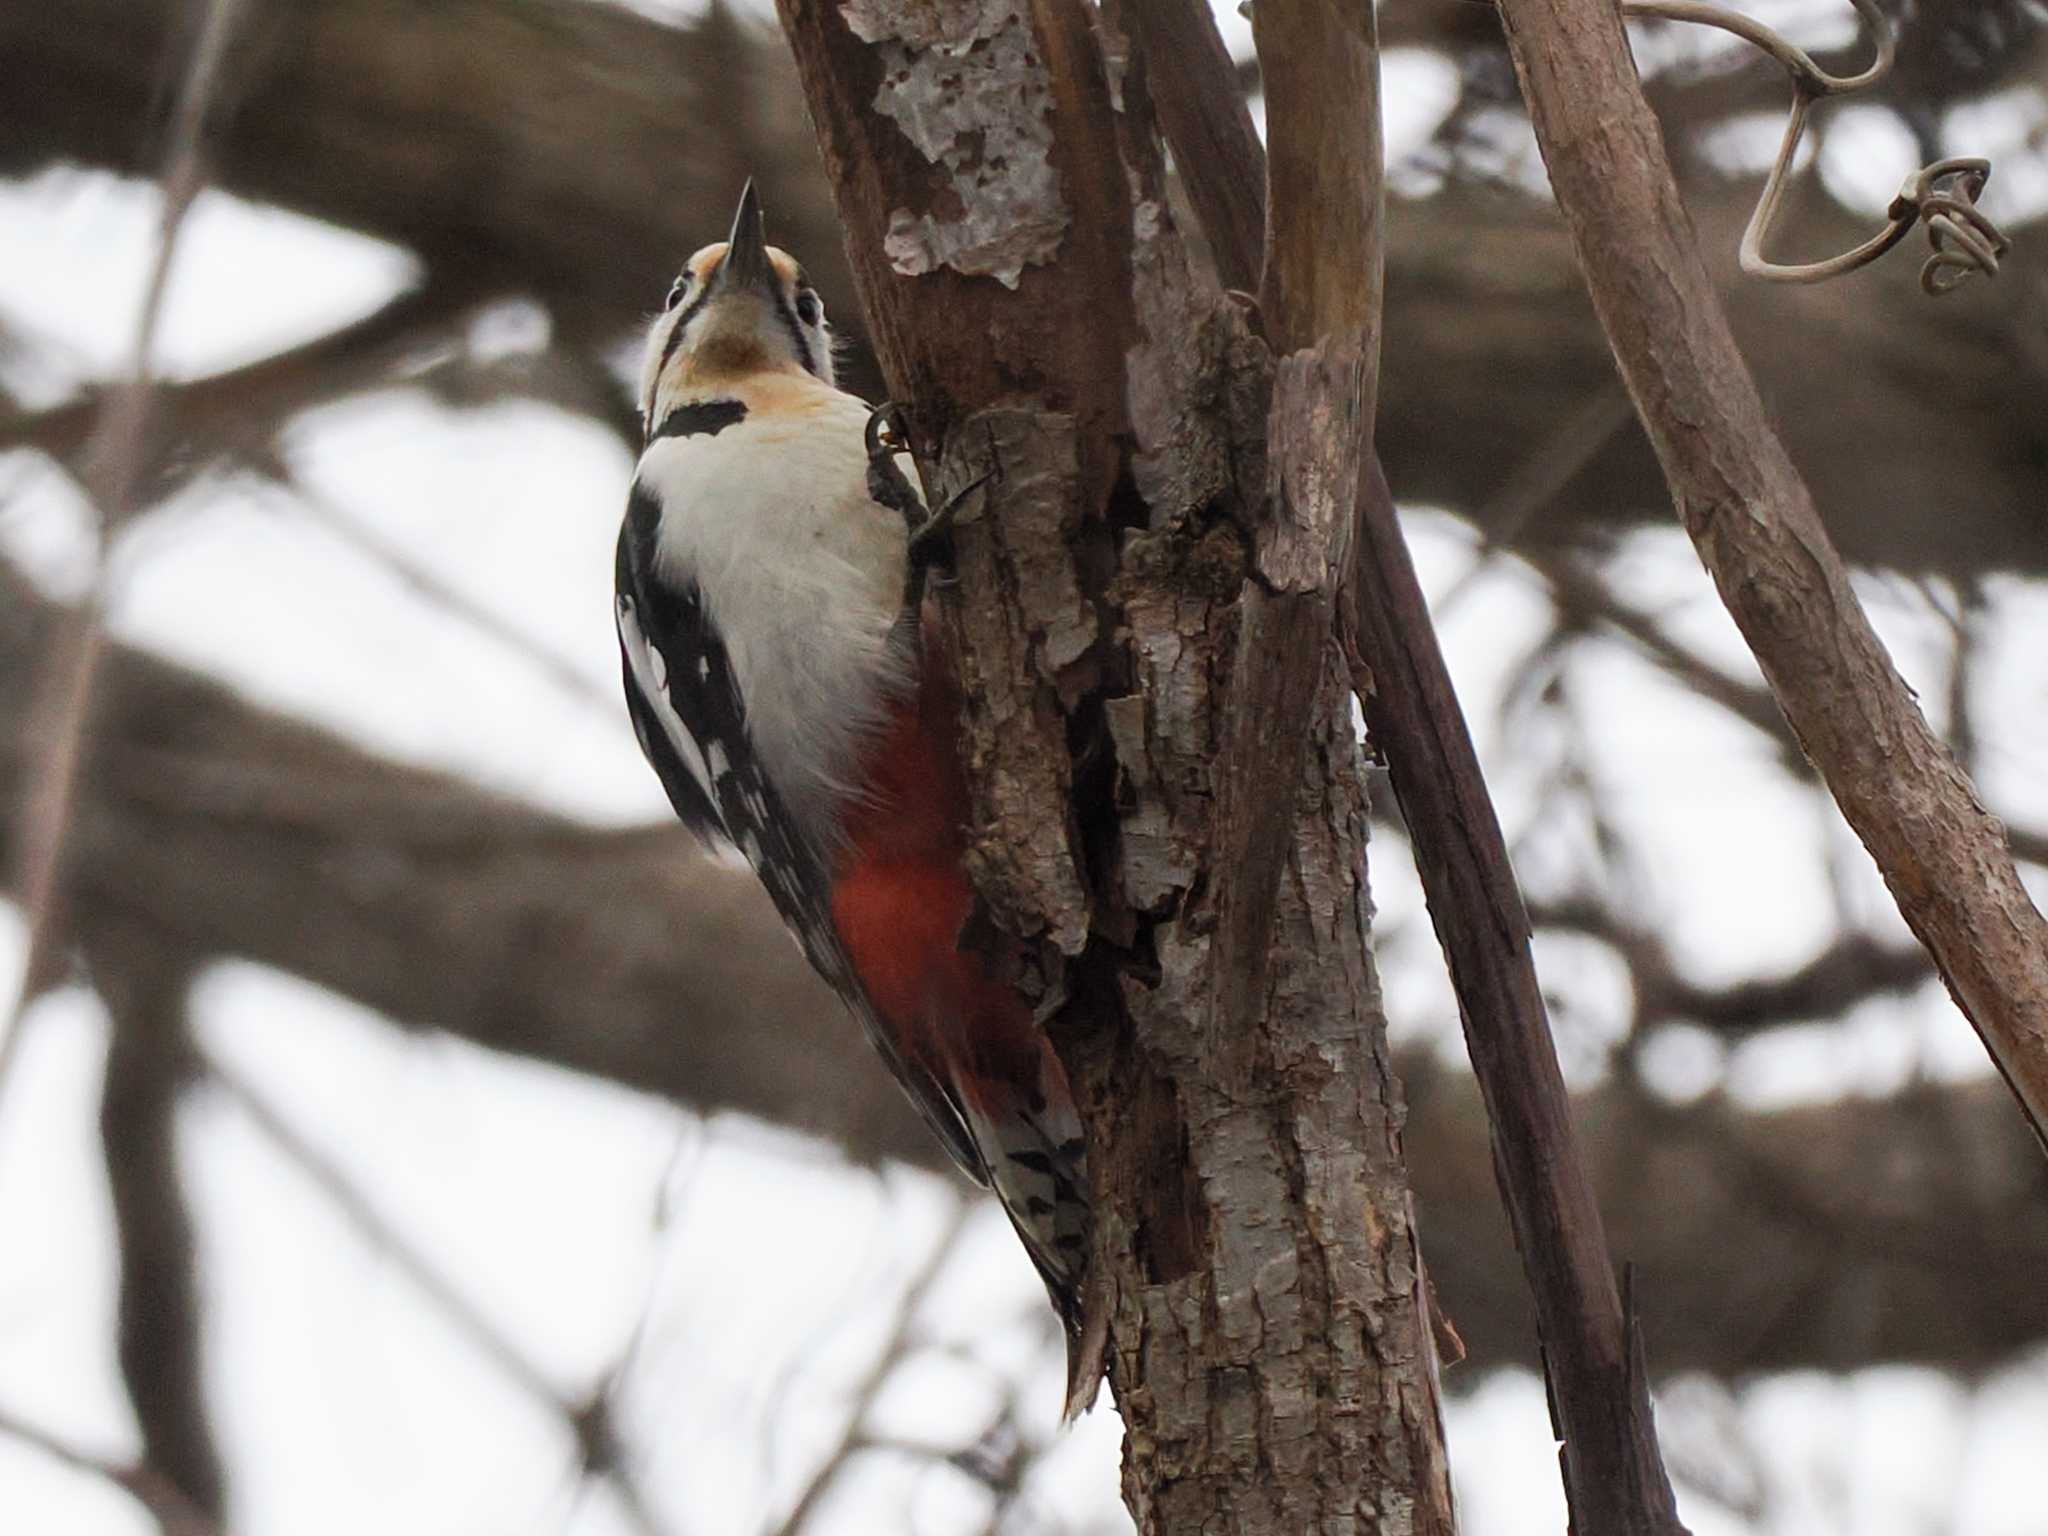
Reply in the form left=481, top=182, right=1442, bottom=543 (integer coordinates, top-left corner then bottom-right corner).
left=0, top=0, right=244, bottom=1083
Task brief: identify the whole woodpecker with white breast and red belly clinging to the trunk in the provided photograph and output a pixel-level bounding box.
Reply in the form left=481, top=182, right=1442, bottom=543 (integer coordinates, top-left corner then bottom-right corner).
left=616, top=182, right=1106, bottom=1419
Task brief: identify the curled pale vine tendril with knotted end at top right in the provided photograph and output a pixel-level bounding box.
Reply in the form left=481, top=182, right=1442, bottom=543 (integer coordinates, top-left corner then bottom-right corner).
left=1622, top=0, right=2011, bottom=297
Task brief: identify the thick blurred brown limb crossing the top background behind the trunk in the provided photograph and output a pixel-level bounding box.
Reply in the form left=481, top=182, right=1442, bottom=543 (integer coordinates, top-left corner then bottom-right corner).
left=0, top=0, right=2048, bottom=571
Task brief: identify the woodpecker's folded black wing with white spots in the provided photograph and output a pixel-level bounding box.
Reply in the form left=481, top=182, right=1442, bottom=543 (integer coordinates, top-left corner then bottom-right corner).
left=616, top=481, right=989, bottom=1184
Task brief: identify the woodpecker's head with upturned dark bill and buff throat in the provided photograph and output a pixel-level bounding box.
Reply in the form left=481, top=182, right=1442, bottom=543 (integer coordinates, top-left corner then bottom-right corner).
left=639, top=180, right=831, bottom=426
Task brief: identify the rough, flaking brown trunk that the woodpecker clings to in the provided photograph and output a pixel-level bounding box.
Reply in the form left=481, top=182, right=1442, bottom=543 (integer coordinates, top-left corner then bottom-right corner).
left=782, top=0, right=1450, bottom=1532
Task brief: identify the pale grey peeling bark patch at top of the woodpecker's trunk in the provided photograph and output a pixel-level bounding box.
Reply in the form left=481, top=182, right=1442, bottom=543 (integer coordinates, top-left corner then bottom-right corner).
left=840, top=0, right=1071, bottom=289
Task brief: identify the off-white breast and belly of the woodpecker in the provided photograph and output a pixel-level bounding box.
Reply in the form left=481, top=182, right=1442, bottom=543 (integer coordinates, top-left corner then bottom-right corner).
left=639, top=387, right=911, bottom=848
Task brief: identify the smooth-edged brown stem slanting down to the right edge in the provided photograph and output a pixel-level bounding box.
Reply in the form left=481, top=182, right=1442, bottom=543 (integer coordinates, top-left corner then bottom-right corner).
left=1501, top=0, right=2048, bottom=1145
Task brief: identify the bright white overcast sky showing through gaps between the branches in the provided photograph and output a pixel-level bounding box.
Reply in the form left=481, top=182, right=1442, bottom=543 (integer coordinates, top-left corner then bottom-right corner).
left=0, top=0, right=2048, bottom=1536
